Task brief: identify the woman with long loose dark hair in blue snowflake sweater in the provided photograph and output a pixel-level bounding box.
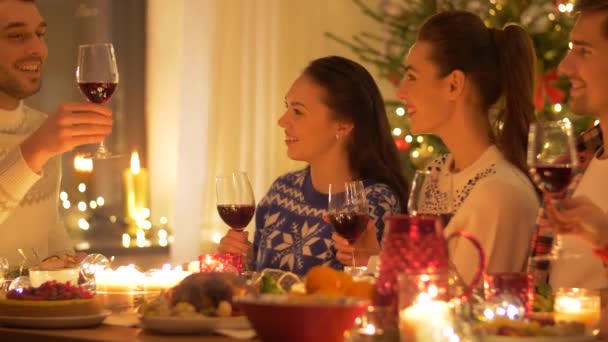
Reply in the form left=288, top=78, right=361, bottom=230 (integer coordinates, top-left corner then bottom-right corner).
left=219, top=56, right=407, bottom=275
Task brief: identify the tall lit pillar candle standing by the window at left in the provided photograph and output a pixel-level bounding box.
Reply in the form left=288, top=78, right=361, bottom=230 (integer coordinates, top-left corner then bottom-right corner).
left=123, top=151, right=149, bottom=233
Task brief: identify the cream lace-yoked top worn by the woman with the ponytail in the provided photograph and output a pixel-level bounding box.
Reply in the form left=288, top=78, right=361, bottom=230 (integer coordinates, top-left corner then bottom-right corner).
left=425, top=146, right=539, bottom=282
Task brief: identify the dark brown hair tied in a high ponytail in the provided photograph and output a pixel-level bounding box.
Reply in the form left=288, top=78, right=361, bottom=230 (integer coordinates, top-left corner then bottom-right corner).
left=418, top=11, right=536, bottom=172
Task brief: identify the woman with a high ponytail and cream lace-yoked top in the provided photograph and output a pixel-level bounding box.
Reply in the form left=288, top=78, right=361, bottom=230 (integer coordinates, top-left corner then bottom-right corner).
left=398, top=11, right=539, bottom=281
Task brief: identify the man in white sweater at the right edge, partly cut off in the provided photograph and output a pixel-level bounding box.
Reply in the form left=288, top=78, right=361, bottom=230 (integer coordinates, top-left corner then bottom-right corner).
left=550, top=0, right=608, bottom=289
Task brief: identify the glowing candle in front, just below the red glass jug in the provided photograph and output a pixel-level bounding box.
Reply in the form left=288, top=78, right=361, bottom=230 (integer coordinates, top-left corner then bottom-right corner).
left=399, top=293, right=454, bottom=342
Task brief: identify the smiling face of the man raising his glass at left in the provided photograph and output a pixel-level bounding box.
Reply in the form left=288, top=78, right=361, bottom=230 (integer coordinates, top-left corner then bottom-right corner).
left=0, top=0, right=48, bottom=109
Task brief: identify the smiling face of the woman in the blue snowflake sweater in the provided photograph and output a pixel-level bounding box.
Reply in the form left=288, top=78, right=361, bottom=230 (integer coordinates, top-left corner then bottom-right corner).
left=279, top=75, right=348, bottom=164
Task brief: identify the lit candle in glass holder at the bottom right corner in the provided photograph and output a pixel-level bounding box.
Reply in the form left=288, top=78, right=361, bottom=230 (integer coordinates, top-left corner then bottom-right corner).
left=553, top=288, right=600, bottom=331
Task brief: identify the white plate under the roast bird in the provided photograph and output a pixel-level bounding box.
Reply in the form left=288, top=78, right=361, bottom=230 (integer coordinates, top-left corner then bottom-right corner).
left=141, top=315, right=251, bottom=334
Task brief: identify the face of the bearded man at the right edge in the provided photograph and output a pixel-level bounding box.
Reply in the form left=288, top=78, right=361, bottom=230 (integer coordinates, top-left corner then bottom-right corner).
left=559, top=11, right=608, bottom=120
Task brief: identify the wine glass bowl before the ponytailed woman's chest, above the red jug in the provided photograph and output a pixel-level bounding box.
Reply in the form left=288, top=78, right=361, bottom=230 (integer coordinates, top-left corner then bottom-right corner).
left=407, top=170, right=454, bottom=228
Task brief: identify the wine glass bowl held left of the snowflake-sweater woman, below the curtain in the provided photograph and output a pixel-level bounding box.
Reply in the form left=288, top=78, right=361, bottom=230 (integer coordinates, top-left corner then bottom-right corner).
left=215, top=171, right=255, bottom=231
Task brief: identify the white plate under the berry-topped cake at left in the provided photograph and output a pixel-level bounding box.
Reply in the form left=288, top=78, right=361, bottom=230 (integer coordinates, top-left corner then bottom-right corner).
left=0, top=311, right=110, bottom=329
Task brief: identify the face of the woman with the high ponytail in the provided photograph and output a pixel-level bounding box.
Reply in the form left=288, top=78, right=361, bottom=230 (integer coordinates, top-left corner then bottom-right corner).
left=397, top=42, right=453, bottom=135
